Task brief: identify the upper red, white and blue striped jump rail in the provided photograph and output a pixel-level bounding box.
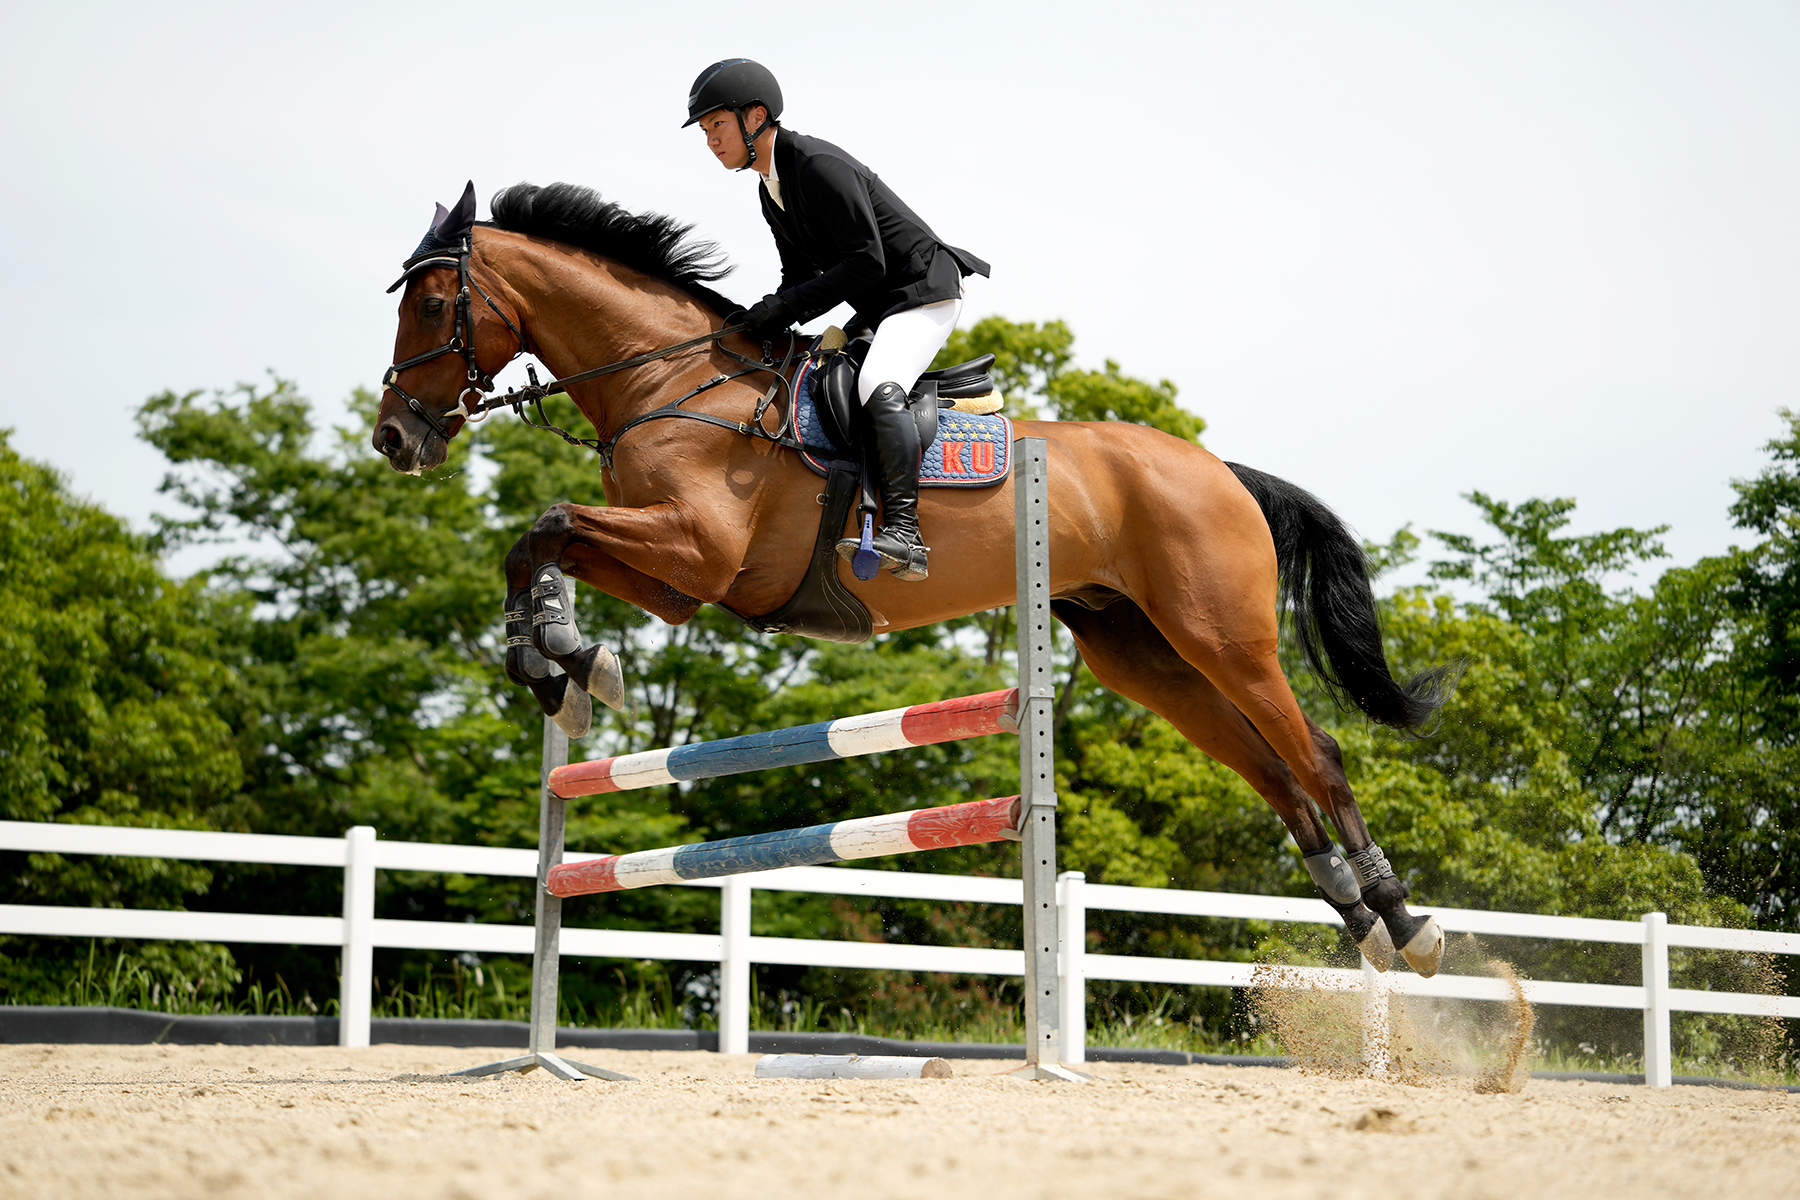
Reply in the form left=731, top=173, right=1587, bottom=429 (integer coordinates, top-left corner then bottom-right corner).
left=551, top=687, right=1019, bottom=802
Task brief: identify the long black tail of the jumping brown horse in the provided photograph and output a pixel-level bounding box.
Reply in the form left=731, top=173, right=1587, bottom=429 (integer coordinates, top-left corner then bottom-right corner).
left=1226, top=462, right=1458, bottom=732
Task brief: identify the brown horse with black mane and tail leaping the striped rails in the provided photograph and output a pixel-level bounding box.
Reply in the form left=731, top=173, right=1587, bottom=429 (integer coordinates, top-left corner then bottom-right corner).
left=373, top=184, right=1449, bottom=975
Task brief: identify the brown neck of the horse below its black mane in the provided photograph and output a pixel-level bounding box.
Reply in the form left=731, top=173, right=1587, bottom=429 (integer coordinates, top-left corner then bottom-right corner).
left=495, top=237, right=716, bottom=437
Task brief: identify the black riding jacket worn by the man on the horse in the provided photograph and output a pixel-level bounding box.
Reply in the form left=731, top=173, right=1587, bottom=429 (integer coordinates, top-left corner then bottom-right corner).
left=756, top=130, right=988, bottom=327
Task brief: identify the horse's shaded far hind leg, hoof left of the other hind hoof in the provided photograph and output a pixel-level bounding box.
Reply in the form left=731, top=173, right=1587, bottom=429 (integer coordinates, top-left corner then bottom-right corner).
left=1051, top=599, right=1393, bottom=972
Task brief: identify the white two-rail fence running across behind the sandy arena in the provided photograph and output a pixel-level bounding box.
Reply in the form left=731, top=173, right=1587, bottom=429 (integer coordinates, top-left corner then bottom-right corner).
left=0, top=820, right=1800, bottom=1087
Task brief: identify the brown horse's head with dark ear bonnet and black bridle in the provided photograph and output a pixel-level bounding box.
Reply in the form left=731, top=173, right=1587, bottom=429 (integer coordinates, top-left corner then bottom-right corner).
left=374, top=182, right=522, bottom=475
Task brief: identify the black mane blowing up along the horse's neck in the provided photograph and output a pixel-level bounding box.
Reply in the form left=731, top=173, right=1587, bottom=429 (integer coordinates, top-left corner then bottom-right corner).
left=482, top=184, right=738, bottom=315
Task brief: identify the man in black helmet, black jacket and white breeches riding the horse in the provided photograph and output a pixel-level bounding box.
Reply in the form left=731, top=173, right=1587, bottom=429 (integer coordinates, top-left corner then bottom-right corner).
left=682, top=58, right=988, bottom=579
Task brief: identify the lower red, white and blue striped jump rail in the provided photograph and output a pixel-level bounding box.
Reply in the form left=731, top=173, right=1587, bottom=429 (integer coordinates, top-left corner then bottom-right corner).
left=544, top=791, right=1019, bottom=898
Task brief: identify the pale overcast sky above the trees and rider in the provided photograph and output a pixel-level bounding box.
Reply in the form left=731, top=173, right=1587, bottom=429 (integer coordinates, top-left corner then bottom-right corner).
left=0, top=0, right=1800, bottom=586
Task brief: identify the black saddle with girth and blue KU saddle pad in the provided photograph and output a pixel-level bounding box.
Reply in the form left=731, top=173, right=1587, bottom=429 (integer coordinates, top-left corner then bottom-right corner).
left=725, top=327, right=1012, bottom=644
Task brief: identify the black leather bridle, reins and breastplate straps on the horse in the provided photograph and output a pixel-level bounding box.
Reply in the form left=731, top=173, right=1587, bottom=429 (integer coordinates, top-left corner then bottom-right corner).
left=382, top=237, right=839, bottom=470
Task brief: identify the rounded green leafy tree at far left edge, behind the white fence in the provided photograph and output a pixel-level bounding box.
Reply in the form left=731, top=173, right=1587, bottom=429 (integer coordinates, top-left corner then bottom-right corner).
left=0, top=430, right=243, bottom=1002
